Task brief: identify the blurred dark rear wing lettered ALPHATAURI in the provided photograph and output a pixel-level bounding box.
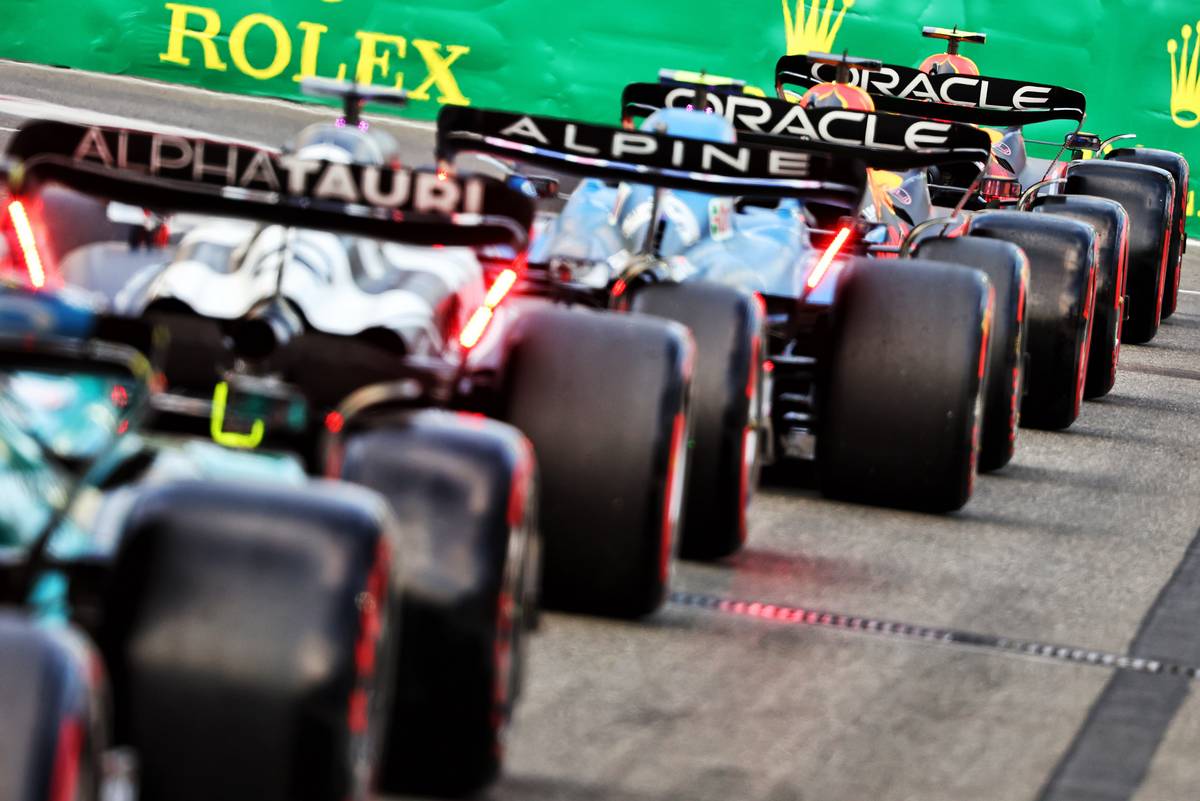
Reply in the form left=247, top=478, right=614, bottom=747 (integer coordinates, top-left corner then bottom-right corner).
left=7, top=121, right=534, bottom=247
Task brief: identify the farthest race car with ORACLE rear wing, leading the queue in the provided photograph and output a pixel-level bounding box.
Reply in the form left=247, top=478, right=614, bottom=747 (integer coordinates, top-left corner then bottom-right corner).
left=776, top=28, right=1188, bottom=347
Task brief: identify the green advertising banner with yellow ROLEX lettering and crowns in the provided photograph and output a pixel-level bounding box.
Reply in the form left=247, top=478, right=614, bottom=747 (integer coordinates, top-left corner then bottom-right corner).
left=7, top=0, right=1200, bottom=234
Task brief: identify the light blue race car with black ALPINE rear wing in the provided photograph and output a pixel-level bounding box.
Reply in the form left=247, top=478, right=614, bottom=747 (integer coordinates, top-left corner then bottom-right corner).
left=438, top=90, right=992, bottom=510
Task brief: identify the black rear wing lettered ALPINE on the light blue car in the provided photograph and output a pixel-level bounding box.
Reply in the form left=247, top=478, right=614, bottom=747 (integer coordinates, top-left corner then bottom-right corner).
left=437, top=106, right=866, bottom=206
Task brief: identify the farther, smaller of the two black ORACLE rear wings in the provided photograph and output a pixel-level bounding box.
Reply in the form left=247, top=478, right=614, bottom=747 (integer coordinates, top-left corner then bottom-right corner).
left=775, top=55, right=1087, bottom=126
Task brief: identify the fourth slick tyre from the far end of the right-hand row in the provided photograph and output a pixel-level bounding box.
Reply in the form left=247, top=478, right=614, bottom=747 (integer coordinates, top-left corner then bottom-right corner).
left=970, top=211, right=1096, bottom=429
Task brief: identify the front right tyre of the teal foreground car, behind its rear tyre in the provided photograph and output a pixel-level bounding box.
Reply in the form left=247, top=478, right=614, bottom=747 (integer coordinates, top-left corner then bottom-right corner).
left=330, top=410, right=539, bottom=795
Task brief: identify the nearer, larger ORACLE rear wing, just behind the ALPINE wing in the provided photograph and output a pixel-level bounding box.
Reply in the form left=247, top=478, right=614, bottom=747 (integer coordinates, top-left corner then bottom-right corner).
left=620, top=83, right=991, bottom=170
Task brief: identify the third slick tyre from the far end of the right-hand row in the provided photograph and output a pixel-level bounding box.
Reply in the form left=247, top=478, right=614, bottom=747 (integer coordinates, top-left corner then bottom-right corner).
left=1033, top=194, right=1129, bottom=398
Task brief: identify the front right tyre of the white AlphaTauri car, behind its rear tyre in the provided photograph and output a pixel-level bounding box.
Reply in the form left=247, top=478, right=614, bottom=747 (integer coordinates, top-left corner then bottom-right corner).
left=631, top=283, right=766, bottom=559
